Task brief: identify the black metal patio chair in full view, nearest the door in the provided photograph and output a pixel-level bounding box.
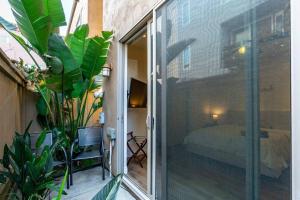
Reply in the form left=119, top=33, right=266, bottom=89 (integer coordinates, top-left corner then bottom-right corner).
left=70, top=127, right=105, bottom=185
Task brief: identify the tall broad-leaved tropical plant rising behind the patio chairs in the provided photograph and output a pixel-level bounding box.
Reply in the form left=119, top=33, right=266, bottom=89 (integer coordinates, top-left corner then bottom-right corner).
left=7, top=0, right=113, bottom=153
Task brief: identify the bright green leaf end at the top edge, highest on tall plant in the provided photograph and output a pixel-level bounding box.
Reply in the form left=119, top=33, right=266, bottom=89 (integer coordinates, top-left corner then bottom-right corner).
left=44, top=0, right=66, bottom=28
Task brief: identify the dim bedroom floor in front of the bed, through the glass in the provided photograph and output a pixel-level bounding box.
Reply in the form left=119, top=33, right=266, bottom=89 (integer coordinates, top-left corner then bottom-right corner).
left=168, top=147, right=290, bottom=200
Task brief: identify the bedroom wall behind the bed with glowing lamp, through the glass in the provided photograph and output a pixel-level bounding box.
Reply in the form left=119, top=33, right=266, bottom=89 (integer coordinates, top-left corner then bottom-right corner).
left=167, top=55, right=290, bottom=145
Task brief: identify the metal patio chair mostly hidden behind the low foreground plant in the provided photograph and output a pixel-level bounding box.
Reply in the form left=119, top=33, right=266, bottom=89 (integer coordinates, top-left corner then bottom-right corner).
left=30, top=132, right=70, bottom=189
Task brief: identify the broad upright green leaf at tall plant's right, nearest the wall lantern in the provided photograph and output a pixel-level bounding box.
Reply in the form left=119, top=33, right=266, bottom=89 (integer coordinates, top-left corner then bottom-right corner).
left=81, top=36, right=110, bottom=79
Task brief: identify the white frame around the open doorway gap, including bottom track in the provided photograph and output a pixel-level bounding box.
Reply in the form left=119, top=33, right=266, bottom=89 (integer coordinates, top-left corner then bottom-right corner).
left=117, top=19, right=155, bottom=200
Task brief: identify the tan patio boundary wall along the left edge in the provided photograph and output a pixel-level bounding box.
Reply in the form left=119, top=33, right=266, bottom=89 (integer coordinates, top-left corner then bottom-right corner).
left=0, top=49, right=40, bottom=158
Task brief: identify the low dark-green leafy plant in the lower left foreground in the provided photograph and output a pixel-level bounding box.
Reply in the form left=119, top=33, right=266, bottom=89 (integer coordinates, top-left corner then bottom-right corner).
left=0, top=123, right=56, bottom=200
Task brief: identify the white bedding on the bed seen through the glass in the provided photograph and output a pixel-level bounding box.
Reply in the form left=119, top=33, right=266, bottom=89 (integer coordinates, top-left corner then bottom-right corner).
left=184, top=125, right=290, bottom=177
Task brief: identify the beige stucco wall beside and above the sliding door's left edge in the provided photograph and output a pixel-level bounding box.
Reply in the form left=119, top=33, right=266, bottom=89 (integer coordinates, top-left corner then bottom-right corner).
left=103, top=0, right=159, bottom=173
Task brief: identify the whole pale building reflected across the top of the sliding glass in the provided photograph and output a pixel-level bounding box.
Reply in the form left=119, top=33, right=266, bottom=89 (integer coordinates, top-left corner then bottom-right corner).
left=167, top=0, right=290, bottom=80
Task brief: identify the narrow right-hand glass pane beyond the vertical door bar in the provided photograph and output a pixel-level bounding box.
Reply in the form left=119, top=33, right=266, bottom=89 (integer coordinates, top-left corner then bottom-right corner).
left=256, top=0, right=291, bottom=200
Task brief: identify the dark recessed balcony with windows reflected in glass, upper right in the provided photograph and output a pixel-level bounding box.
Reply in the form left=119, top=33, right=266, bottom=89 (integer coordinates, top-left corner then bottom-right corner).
left=221, top=1, right=290, bottom=70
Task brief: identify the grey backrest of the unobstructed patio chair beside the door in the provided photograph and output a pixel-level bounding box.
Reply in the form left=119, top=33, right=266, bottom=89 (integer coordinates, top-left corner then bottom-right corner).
left=78, top=127, right=103, bottom=147
